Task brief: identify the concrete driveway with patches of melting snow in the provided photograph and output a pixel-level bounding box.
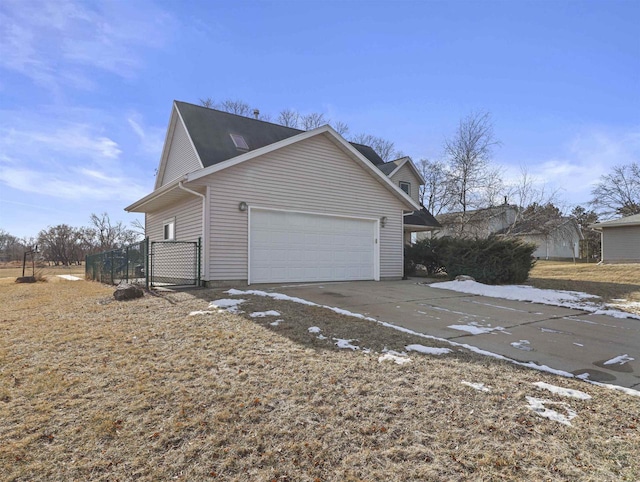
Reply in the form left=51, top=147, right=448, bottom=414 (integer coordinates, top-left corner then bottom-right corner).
left=272, top=280, right=640, bottom=389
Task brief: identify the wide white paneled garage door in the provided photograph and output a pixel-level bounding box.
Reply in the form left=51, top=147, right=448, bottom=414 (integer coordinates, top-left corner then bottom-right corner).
left=249, top=209, right=376, bottom=283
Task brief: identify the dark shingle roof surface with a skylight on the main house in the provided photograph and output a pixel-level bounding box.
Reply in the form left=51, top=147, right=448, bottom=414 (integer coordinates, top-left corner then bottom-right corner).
left=176, top=101, right=384, bottom=167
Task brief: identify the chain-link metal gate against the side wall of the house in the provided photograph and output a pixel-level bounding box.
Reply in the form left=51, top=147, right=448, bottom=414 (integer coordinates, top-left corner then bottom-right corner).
left=149, top=239, right=201, bottom=287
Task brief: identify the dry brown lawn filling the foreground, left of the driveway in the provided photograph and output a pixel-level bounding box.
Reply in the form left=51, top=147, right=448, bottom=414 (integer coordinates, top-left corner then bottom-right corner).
left=0, top=278, right=640, bottom=482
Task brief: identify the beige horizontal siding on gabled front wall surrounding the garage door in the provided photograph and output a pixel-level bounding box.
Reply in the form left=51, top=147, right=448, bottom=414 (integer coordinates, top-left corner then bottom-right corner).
left=198, top=136, right=404, bottom=280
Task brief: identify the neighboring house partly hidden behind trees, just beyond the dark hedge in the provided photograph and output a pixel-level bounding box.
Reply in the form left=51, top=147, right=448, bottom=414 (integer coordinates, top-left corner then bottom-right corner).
left=499, top=217, right=584, bottom=259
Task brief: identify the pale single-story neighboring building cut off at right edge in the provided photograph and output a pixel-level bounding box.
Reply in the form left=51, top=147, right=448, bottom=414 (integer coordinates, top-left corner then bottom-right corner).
left=590, top=214, right=640, bottom=263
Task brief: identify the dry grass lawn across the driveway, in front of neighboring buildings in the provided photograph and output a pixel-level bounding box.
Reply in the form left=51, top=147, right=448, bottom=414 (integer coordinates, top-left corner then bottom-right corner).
left=527, top=261, right=640, bottom=301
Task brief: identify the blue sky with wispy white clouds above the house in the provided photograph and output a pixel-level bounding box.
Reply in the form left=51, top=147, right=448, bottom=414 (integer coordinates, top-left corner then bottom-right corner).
left=0, top=0, right=640, bottom=236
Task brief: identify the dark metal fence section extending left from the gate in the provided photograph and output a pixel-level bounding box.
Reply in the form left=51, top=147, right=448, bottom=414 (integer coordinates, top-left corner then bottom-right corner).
left=85, top=238, right=149, bottom=287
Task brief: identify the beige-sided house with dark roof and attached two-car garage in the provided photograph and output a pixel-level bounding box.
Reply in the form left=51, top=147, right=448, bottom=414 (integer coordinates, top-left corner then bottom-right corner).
left=126, top=101, right=437, bottom=283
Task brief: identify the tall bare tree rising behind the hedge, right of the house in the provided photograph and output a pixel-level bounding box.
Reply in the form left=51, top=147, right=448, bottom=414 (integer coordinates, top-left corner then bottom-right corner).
left=444, top=112, right=500, bottom=223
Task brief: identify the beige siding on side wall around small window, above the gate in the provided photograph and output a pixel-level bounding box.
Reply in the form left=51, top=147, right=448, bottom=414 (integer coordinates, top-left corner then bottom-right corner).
left=146, top=196, right=202, bottom=241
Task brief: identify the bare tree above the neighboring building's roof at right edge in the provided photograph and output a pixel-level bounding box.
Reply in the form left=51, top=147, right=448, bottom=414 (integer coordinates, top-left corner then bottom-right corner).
left=589, top=162, right=640, bottom=217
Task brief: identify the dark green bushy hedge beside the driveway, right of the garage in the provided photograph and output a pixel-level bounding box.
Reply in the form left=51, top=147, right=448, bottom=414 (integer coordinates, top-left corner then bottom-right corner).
left=405, top=238, right=536, bottom=284
